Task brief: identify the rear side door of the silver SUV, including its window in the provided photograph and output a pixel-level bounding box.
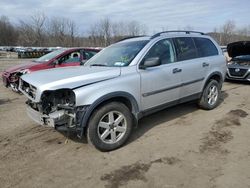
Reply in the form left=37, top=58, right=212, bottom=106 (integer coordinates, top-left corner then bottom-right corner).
left=174, top=37, right=209, bottom=99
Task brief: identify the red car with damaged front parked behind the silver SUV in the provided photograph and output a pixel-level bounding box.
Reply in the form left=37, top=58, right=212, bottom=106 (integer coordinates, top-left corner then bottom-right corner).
left=2, top=48, right=100, bottom=92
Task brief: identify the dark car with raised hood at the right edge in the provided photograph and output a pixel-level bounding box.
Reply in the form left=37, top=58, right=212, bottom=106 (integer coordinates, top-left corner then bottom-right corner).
left=226, top=41, right=250, bottom=81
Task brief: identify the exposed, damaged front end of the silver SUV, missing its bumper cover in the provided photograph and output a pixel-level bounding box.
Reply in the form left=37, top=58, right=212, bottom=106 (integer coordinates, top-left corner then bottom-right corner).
left=26, top=89, right=87, bottom=136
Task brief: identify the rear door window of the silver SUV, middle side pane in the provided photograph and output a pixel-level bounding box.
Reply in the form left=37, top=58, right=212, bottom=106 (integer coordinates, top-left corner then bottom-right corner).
left=174, top=37, right=198, bottom=61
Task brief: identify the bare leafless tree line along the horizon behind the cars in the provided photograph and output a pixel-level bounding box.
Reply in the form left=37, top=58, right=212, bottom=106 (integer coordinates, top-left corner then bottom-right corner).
left=0, top=13, right=250, bottom=47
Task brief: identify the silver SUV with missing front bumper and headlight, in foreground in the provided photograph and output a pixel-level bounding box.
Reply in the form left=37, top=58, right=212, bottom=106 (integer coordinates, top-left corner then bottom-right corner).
left=19, top=31, right=226, bottom=151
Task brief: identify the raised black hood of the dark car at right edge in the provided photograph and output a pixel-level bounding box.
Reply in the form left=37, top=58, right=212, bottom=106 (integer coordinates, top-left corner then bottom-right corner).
left=227, top=41, right=250, bottom=58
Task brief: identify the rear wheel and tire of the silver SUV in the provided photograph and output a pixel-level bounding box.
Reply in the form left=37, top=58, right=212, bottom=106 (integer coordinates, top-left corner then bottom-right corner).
left=198, top=79, right=221, bottom=110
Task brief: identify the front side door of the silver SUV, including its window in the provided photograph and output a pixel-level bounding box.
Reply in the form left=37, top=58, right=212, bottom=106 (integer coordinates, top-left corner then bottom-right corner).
left=139, top=39, right=181, bottom=111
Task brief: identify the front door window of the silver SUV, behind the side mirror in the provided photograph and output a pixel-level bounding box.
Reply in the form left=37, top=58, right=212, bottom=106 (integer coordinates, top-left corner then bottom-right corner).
left=145, top=39, right=174, bottom=64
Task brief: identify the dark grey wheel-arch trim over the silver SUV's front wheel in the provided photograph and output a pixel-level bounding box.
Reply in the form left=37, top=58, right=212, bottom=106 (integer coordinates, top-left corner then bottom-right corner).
left=80, top=91, right=139, bottom=128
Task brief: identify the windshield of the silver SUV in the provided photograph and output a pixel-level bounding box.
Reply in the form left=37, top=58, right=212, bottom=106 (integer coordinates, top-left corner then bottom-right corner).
left=85, top=40, right=148, bottom=67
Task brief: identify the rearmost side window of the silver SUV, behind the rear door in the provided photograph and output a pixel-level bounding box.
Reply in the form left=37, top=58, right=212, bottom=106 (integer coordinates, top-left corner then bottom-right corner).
left=194, top=37, right=218, bottom=57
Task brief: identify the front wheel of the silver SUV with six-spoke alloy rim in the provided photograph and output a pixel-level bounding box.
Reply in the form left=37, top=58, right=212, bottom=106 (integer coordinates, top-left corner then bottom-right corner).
left=87, top=102, right=133, bottom=151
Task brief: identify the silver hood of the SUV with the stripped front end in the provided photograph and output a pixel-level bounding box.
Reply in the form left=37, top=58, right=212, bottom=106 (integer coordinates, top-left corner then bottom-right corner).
left=21, top=66, right=120, bottom=92
